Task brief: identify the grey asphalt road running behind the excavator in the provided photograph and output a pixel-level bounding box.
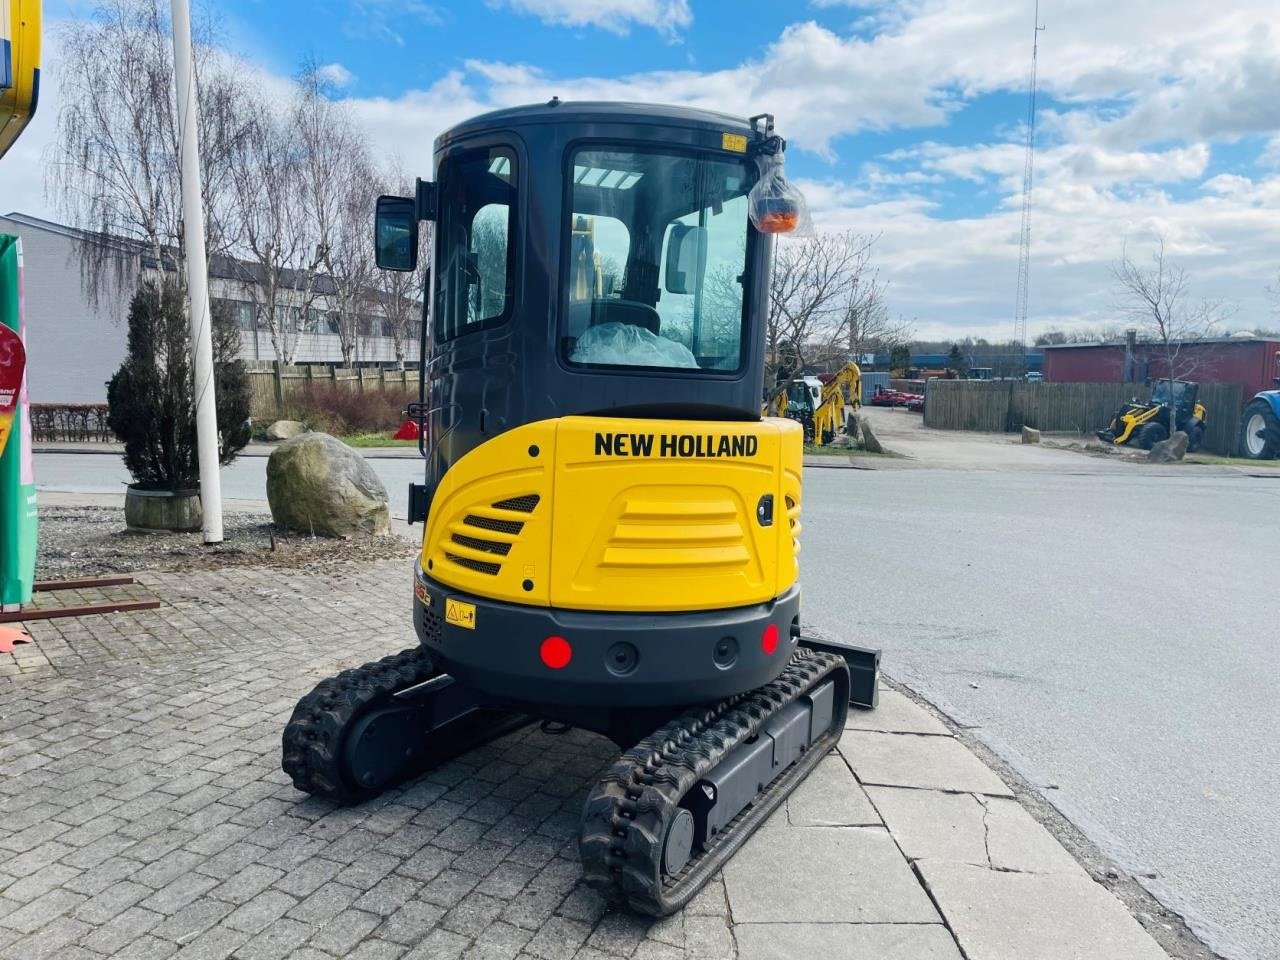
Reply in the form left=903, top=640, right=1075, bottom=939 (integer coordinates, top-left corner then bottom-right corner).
left=36, top=440, right=1280, bottom=960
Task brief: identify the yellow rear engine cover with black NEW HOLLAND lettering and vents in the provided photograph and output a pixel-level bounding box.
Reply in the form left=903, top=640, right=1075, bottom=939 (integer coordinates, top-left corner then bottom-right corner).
left=422, top=417, right=804, bottom=612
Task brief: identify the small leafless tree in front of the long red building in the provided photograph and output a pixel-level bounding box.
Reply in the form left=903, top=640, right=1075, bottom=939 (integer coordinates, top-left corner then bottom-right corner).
left=1111, top=236, right=1230, bottom=419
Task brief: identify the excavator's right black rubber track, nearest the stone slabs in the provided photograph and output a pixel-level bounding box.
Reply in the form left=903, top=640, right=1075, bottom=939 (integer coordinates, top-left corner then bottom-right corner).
left=579, top=648, right=849, bottom=916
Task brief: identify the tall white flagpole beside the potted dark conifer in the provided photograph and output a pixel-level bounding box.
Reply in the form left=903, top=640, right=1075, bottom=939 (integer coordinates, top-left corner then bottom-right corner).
left=170, top=0, right=223, bottom=544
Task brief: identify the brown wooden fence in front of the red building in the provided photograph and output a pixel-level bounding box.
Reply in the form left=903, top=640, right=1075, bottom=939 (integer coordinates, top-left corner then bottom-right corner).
left=924, top=380, right=1244, bottom=456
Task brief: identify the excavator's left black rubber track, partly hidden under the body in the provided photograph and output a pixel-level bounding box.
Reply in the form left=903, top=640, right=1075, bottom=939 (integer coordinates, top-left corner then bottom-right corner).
left=280, top=646, right=440, bottom=804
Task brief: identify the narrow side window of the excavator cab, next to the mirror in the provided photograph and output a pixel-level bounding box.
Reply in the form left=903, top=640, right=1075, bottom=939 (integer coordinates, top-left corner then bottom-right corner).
left=435, top=147, right=517, bottom=340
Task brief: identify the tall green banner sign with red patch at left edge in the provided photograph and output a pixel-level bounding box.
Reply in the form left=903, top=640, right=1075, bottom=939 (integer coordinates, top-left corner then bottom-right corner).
left=0, top=234, right=36, bottom=608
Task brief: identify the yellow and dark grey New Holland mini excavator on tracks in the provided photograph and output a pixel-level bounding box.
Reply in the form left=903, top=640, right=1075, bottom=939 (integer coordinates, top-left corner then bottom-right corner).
left=284, top=100, right=874, bottom=914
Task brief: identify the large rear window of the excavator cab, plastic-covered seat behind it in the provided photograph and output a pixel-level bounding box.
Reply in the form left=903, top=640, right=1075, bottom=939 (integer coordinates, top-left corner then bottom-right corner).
left=561, top=146, right=751, bottom=372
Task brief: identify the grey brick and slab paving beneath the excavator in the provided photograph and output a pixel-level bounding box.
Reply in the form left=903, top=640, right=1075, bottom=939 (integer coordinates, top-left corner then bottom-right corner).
left=0, top=561, right=1165, bottom=960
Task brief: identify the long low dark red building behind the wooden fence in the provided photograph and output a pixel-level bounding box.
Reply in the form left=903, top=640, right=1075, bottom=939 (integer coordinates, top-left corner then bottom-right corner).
left=1044, top=337, right=1280, bottom=399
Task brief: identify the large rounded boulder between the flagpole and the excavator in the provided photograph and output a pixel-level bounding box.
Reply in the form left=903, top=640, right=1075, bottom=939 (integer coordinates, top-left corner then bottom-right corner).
left=266, top=433, right=390, bottom=539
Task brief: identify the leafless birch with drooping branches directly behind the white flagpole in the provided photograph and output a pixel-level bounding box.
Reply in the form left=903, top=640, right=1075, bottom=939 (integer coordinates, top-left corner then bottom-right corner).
left=45, top=0, right=243, bottom=302
